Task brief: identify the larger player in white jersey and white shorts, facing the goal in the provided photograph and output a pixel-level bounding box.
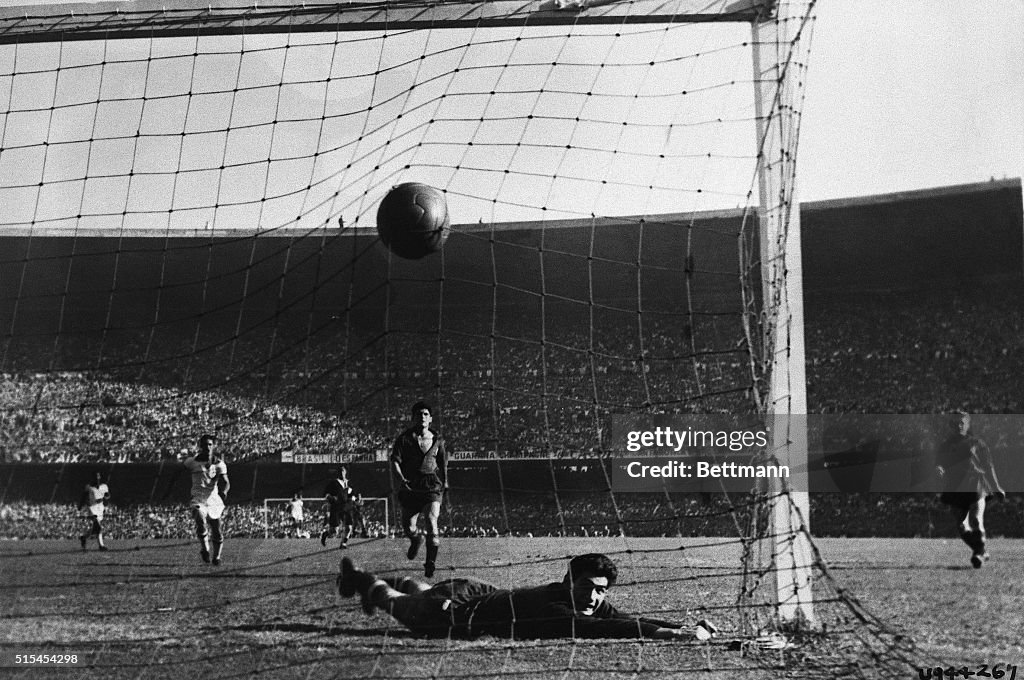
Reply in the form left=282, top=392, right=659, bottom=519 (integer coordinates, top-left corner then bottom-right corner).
left=184, top=434, right=231, bottom=566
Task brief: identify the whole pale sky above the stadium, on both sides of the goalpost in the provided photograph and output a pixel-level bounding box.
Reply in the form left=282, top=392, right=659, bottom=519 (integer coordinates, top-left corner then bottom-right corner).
left=0, top=0, right=1024, bottom=229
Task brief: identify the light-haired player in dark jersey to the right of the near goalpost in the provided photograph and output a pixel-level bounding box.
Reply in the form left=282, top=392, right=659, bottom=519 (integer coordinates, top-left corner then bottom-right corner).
left=935, top=412, right=1007, bottom=569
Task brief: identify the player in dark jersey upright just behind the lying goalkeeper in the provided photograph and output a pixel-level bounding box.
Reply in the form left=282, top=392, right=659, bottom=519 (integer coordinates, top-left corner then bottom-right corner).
left=391, top=401, right=447, bottom=579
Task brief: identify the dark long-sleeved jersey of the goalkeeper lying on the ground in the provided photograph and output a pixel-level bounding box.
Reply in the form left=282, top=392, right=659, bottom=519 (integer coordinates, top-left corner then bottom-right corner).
left=453, top=583, right=679, bottom=639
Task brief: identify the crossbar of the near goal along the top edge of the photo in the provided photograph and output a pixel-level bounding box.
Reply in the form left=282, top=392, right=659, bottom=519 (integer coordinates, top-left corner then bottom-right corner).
left=0, top=0, right=776, bottom=44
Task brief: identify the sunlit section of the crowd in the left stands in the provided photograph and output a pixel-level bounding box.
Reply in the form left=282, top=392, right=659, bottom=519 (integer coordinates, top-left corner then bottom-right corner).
left=0, top=372, right=371, bottom=463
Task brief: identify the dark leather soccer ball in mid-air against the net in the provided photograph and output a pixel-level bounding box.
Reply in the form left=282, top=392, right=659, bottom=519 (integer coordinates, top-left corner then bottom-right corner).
left=377, top=182, right=452, bottom=260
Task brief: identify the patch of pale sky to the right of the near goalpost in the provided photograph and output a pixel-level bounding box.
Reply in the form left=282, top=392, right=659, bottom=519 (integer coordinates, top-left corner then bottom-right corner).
left=800, top=0, right=1024, bottom=200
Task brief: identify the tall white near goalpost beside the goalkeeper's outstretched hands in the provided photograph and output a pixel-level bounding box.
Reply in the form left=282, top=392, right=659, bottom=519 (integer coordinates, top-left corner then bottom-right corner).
left=751, top=5, right=814, bottom=624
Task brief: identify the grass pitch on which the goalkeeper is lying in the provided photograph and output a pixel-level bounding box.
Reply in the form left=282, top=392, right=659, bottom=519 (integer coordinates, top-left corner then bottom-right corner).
left=0, top=539, right=1024, bottom=680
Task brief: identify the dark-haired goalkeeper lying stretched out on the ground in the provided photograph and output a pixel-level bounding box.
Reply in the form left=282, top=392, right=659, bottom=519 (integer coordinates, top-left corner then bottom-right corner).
left=338, top=554, right=716, bottom=640
